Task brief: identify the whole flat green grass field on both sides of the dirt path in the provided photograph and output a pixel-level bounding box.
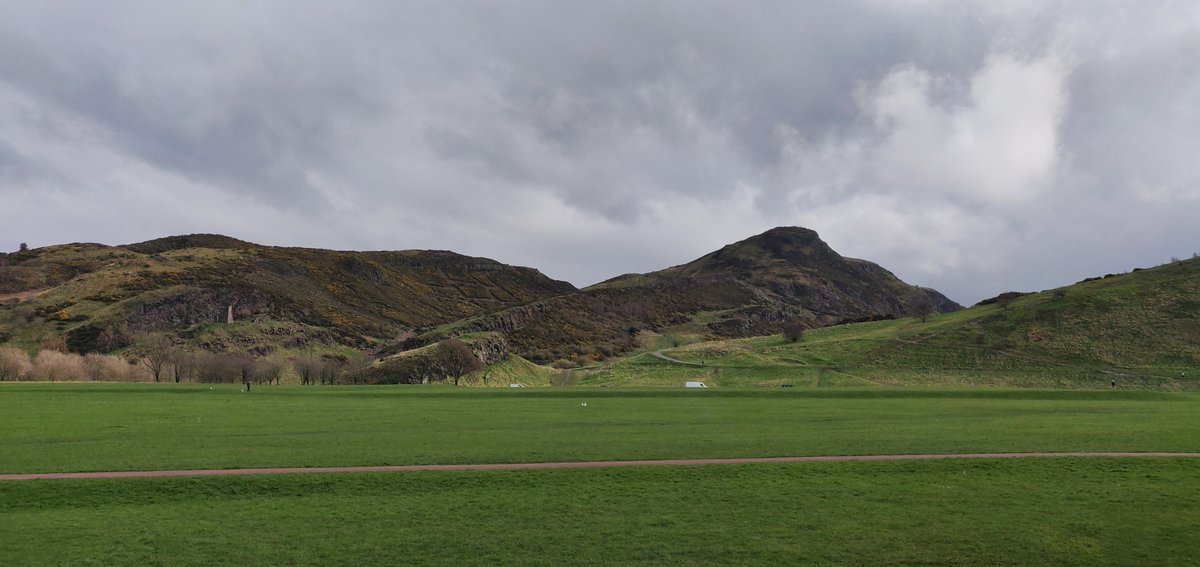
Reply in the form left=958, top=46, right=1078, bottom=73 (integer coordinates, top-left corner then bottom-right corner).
left=0, top=383, right=1200, bottom=566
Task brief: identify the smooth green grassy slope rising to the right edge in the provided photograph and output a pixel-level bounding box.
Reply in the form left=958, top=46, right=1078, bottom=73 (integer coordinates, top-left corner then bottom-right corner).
left=576, top=259, right=1200, bottom=388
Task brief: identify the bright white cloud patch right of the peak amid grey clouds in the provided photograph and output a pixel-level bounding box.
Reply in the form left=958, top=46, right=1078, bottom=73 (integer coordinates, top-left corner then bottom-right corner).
left=863, top=47, right=1069, bottom=205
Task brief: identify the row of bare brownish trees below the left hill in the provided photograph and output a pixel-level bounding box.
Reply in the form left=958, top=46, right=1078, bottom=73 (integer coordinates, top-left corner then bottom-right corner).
left=0, top=347, right=358, bottom=384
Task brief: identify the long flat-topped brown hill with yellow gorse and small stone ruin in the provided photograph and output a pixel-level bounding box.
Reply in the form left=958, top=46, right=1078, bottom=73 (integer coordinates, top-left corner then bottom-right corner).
left=0, top=234, right=575, bottom=352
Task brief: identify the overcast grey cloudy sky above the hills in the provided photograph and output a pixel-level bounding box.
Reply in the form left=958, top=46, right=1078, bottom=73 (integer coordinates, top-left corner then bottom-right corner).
left=0, top=0, right=1200, bottom=304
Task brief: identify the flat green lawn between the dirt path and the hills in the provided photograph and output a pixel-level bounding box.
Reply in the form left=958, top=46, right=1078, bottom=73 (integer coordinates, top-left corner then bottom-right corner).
left=0, top=384, right=1200, bottom=472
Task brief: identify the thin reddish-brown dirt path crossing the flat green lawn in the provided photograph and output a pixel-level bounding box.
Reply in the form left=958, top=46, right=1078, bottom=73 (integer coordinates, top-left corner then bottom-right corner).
left=0, top=453, right=1200, bottom=481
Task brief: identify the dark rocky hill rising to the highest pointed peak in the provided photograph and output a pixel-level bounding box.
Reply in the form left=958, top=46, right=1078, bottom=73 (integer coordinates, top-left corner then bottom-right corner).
left=408, top=227, right=961, bottom=365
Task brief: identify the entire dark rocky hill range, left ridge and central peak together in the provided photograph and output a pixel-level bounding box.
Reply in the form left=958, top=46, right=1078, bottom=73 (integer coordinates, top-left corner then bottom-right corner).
left=0, top=228, right=959, bottom=363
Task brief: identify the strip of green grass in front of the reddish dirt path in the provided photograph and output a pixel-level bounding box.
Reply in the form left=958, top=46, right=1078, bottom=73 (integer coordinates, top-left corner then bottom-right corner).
left=0, top=459, right=1200, bottom=566
